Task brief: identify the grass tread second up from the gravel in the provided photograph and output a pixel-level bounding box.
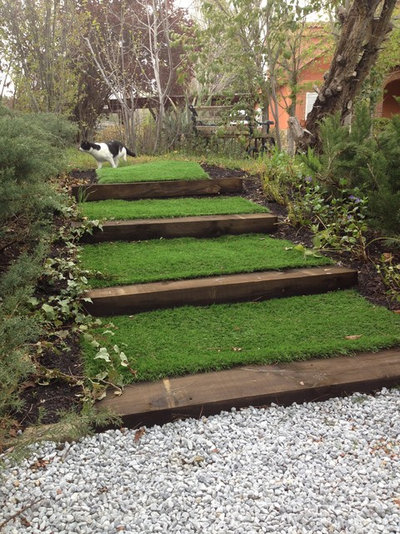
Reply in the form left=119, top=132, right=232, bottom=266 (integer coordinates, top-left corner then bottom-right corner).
left=81, top=234, right=333, bottom=287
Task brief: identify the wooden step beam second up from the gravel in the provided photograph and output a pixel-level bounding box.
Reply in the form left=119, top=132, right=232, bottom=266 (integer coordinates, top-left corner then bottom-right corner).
left=85, top=267, right=357, bottom=317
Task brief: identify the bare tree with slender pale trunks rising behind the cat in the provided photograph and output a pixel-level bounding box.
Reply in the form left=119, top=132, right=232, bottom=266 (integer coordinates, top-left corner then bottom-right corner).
left=85, top=0, right=191, bottom=151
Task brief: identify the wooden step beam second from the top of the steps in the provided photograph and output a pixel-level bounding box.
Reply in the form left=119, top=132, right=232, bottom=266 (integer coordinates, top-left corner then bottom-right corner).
left=81, top=215, right=277, bottom=243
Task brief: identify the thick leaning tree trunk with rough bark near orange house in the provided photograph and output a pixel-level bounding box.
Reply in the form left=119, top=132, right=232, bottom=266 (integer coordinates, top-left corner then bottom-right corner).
left=298, top=0, right=396, bottom=150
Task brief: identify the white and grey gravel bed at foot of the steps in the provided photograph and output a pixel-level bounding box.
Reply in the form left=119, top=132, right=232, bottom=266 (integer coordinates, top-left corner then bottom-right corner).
left=0, top=389, right=400, bottom=534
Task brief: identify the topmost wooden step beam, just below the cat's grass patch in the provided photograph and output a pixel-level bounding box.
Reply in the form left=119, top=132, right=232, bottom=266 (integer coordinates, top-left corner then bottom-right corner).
left=72, top=178, right=243, bottom=201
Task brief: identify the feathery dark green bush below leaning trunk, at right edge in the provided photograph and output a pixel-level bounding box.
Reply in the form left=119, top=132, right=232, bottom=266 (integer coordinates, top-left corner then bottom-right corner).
left=300, top=105, right=400, bottom=235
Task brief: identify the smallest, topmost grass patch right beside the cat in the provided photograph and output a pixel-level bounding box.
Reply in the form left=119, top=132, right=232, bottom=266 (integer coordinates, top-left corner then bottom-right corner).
left=96, top=160, right=209, bottom=184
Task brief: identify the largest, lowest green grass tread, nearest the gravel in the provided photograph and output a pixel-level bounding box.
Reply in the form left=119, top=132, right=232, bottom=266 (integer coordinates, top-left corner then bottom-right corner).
left=83, top=290, right=400, bottom=383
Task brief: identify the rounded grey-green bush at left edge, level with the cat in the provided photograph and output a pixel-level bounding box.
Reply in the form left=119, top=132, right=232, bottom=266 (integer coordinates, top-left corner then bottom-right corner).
left=0, top=108, right=73, bottom=247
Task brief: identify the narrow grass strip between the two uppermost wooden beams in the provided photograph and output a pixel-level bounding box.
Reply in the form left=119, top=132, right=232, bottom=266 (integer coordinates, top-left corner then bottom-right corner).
left=79, top=196, right=269, bottom=220
